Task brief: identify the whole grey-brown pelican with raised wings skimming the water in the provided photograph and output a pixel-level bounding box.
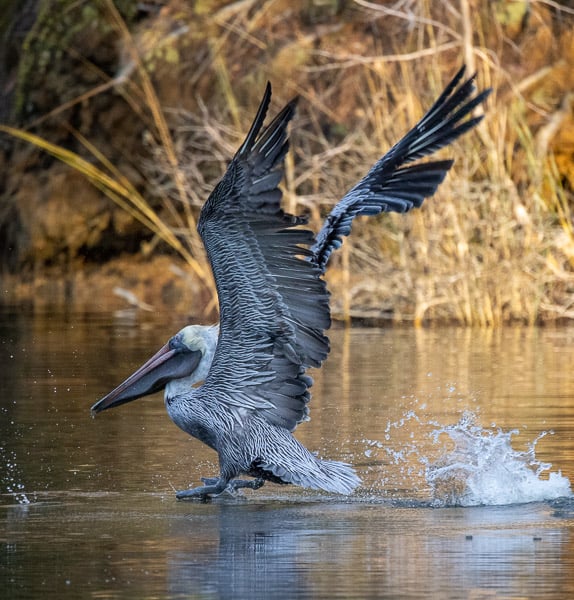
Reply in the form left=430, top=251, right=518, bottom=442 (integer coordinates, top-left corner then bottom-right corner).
left=92, top=67, right=490, bottom=498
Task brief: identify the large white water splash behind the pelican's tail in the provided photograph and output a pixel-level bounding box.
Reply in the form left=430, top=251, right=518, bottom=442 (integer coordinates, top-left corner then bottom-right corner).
left=364, top=411, right=572, bottom=507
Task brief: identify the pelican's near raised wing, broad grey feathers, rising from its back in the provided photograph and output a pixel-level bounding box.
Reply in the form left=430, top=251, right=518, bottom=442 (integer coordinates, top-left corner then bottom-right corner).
left=198, top=84, right=330, bottom=430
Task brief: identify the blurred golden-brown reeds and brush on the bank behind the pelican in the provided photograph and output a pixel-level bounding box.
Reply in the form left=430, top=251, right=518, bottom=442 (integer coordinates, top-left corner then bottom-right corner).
left=0, top=0, right=574, bottom=326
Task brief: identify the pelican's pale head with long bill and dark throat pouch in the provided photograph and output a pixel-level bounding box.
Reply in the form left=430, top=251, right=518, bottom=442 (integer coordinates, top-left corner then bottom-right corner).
left=91, top=325, right=219, bottom=415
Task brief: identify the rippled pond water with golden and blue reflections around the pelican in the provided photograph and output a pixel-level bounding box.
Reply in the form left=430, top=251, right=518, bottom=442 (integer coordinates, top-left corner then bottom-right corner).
left=0, top=312, right=574, bottom=599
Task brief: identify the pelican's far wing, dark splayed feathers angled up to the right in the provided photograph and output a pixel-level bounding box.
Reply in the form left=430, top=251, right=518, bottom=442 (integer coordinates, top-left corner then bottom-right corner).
left=311, top=66, right=491, bottom=271
